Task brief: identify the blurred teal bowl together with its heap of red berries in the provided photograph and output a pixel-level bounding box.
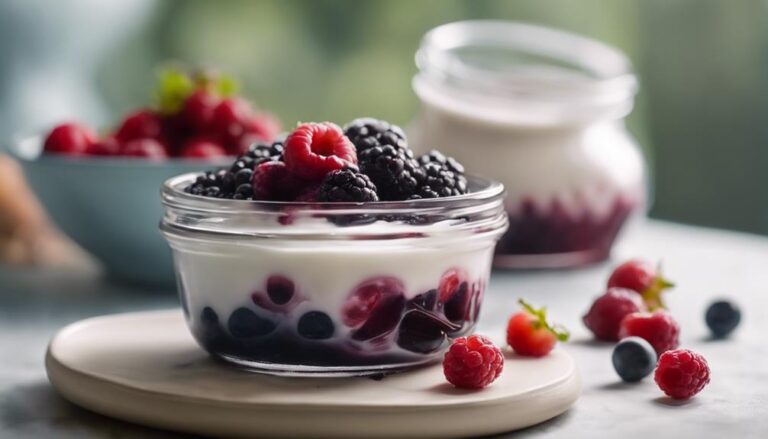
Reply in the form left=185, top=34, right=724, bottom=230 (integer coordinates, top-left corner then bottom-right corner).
left=10, top=70, right=281, bottom=286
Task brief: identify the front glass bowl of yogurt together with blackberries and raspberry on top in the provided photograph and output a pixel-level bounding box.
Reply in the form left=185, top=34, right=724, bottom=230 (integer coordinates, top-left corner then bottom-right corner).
left=160, top=118, right=507, bottom=376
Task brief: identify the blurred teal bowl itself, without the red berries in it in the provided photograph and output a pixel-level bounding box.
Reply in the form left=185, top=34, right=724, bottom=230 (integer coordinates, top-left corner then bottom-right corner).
left=9, top=137, right=228, bottom=287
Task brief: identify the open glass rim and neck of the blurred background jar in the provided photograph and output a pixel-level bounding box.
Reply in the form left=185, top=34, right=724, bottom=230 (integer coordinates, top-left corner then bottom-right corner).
left=413, top=20, right=637, bottom=125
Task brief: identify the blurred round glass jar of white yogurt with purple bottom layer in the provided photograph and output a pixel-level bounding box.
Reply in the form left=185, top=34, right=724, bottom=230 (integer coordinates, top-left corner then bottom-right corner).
left=408, top=21, right=647, bottom=268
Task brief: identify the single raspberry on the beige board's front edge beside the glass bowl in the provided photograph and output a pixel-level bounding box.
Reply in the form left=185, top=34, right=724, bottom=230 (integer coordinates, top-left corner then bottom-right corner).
left=443, top=335, right=504, bottom=389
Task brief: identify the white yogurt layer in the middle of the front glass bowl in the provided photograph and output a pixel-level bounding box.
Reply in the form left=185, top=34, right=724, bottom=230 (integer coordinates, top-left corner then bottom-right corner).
left=172, top=240, right=493, bottom=328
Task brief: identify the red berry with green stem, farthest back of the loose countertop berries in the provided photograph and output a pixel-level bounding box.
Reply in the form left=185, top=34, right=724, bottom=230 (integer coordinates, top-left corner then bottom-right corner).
left=608, top=259, right=674, bottom=310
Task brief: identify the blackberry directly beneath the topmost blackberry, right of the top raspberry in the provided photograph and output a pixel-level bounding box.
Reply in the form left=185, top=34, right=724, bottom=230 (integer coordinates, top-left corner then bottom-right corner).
left=358, top=145, right=422, bottom=201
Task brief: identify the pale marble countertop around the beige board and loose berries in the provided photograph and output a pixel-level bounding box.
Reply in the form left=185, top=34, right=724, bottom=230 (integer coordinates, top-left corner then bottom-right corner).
left=0, top=221, right=768, bottom=439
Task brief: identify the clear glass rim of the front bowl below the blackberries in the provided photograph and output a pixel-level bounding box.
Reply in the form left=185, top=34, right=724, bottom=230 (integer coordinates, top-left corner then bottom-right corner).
left=160, top=173, right=508, bottom=244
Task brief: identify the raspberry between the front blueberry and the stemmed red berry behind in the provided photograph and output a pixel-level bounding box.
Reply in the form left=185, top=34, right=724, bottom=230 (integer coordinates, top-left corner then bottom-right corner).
left=619, top=311, right=680, bottom=355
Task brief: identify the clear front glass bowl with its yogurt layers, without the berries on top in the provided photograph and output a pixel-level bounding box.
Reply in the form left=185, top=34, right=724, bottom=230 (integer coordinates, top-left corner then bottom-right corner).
left=160, top=174, right=507, bottom=376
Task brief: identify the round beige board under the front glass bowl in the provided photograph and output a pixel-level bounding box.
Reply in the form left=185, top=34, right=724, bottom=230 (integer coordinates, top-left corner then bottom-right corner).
left=46, top=311, right=580, bottom=437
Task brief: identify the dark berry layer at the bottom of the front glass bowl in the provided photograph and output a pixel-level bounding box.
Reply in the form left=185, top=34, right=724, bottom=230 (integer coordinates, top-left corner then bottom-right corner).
left=182, top=269, right=483, bottom=366
